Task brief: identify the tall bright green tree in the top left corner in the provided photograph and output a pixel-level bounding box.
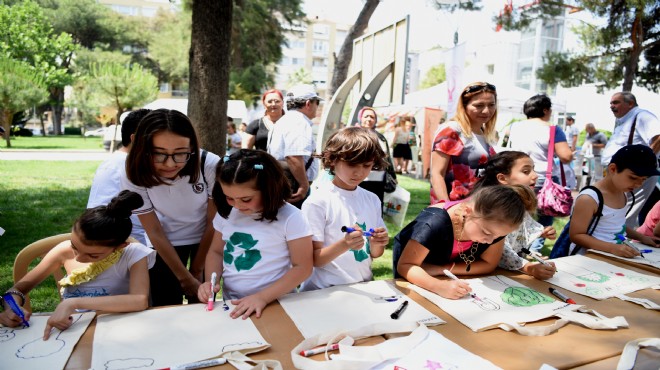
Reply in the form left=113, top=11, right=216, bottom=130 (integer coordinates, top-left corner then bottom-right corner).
left=0, top=1, right=77, bottom=134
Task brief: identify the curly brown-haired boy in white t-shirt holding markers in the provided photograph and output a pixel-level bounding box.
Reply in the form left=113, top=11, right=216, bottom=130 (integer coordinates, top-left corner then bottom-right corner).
left=301, top=127, right=389, bottom=291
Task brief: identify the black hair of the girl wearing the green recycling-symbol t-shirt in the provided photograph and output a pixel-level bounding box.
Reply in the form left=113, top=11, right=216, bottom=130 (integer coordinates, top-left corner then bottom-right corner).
left=213, top=149, right=291, bottom=221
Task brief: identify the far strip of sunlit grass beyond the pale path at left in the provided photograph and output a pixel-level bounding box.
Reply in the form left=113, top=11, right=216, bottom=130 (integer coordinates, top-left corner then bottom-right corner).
left=0, top=135, right=103, bottom=150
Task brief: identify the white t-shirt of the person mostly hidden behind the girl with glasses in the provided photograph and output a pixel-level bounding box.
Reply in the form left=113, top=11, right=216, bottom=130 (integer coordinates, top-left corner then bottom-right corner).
left=87, top=150, right=146, bottom=244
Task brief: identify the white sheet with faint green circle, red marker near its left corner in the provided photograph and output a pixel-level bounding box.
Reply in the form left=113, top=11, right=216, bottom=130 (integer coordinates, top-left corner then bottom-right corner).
left=546, top=255, right=660, bottom=299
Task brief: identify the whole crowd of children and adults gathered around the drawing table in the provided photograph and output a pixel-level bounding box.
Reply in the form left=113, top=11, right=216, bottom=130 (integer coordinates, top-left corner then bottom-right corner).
left=0, top=82, right=660, bottom=339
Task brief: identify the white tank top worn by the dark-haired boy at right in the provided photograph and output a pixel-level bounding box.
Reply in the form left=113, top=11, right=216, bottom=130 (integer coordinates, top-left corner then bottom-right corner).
left=569, top=189, right=630, bottom=255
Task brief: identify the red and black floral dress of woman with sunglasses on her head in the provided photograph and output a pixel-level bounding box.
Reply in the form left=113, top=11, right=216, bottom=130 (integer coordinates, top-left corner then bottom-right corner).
left=431, top=121, right=495, bottom=204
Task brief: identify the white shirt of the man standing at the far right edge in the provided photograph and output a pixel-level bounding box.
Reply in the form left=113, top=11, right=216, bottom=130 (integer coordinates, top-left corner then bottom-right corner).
left=601, top=107, right=660, bottom=166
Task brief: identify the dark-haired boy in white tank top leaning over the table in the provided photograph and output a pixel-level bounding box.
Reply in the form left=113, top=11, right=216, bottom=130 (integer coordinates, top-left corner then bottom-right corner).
left=569, top=144, right=660, bottom=258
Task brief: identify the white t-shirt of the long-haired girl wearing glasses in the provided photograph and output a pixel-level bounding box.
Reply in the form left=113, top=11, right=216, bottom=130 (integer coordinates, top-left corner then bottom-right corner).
left=121, top=152, right=220, bottom=247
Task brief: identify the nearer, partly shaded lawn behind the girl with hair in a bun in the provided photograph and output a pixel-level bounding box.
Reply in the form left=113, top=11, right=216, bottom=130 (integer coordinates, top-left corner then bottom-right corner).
left=0, top=161, right=99, bottom=312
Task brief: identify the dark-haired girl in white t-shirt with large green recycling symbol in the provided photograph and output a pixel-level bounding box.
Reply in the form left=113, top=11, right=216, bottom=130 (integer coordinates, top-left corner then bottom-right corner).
left=197, top=149, right=312, bottom=319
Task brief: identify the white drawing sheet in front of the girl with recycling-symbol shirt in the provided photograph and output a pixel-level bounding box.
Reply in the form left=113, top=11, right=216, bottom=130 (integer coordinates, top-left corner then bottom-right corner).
left=92, top=302, right=270, bottom=370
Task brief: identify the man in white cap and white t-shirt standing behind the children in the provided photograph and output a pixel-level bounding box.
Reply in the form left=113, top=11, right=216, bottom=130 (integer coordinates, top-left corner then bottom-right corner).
left=268, top=85, right=323, bottom=208
